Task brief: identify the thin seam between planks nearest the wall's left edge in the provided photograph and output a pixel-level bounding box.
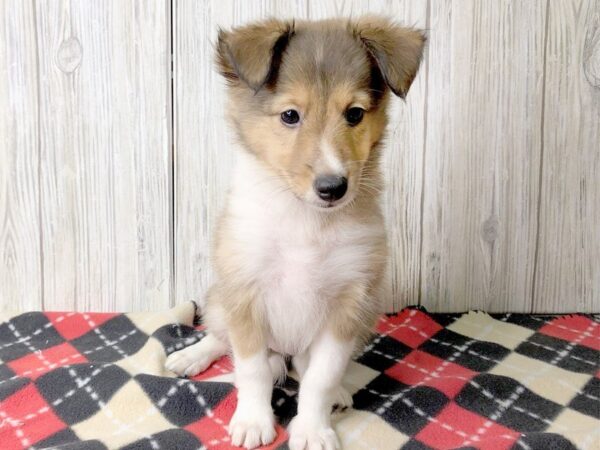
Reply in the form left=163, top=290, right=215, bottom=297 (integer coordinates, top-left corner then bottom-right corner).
left=31, top=0, right=46, bottom=311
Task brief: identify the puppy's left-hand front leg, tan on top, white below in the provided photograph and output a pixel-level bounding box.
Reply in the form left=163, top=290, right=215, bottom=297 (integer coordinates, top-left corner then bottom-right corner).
left=229, top=326, right=276, bottom=449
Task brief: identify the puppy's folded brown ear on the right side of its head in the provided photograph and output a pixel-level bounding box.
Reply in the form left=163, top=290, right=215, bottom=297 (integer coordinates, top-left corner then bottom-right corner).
left=354, top=16, right=426, bottom=98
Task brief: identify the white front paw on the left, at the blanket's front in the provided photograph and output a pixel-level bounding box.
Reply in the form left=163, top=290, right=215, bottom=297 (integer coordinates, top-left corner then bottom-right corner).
left=229, top=408, right=277, bottom=449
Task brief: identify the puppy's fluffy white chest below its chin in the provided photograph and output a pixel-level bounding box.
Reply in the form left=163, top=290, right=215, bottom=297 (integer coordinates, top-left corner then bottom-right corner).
left=244, top=218, right=361, bottom=354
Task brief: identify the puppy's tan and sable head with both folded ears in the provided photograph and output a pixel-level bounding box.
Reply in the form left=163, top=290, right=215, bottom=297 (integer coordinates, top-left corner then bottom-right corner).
left=217, top=17, right=425, bottom=210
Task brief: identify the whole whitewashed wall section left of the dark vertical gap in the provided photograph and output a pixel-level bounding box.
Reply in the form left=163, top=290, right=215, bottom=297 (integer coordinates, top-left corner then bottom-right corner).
left=0, top=0, right=172, bottom=311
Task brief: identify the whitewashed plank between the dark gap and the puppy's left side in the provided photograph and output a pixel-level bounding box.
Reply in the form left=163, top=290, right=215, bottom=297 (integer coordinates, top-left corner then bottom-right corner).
left=173, top=0, right=306, bottom=301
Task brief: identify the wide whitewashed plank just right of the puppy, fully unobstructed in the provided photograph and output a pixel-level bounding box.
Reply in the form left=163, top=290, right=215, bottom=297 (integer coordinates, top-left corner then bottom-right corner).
left=421, top=0, right=546, bottom=311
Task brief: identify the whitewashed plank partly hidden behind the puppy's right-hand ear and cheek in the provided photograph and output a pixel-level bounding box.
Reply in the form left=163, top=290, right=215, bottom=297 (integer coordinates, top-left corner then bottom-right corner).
left=309, top=0, right=428, bottom=311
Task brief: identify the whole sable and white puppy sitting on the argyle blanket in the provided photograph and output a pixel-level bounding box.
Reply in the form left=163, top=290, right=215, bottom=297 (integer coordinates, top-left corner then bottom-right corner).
left=166, top=17, right=425, bottom=450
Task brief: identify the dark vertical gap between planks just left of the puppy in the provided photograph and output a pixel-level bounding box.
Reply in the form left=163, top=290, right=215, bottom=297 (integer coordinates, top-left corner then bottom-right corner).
left=167, top=0, right=177, bottom=307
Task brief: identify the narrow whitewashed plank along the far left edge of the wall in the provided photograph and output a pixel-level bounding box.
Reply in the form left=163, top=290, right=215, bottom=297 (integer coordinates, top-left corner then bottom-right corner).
left=0, top=0, right=42, bottom=310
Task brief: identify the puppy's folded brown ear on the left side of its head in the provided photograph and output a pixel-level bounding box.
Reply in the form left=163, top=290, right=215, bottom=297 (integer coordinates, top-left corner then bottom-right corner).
left=216, top=19, right=294, bottom=91
